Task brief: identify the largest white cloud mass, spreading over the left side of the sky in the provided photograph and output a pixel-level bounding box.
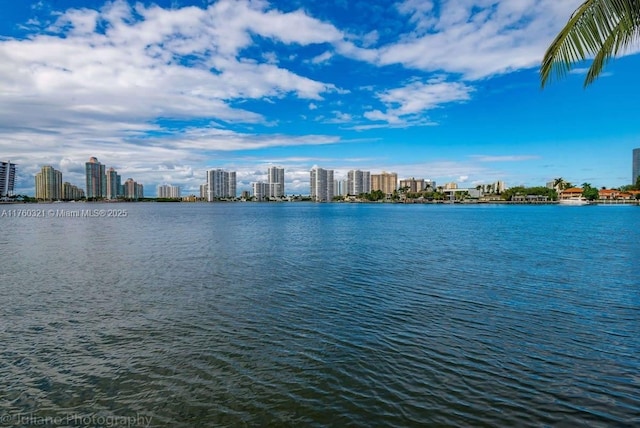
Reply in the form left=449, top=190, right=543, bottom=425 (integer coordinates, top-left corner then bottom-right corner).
left=0, top=0, right=356, bottom=194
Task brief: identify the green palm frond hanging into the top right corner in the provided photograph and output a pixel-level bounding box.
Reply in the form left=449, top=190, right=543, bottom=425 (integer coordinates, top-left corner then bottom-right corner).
left=540, top=0, right=640, bottom=88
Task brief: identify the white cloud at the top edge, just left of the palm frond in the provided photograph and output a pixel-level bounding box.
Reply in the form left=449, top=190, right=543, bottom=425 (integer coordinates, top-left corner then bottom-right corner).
left=375, top=0, right=581, bottom=80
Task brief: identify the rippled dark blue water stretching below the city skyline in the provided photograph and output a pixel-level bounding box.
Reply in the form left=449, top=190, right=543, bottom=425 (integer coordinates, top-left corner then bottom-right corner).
left=0, top=203, right=640, bottom=427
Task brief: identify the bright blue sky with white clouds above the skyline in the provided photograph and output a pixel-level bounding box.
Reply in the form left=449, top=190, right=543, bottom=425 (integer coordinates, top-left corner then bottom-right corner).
left=0, top=0, right=640, bottom=196
